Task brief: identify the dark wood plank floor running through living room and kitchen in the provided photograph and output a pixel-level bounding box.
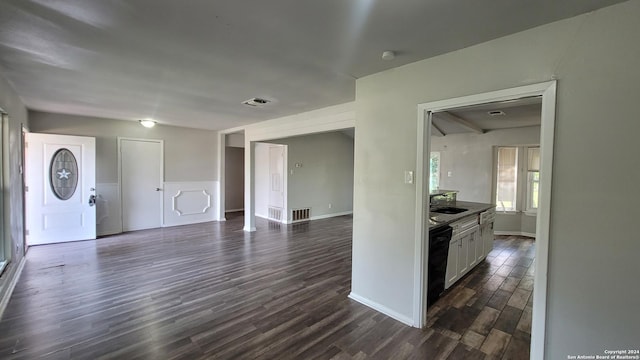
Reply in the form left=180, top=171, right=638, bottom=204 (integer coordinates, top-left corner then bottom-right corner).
left=0, top=212, right=534, bottom=359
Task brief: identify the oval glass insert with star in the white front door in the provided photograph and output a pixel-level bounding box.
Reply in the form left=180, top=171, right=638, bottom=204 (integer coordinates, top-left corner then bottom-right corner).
left=49, top=148, right=78, bottom=200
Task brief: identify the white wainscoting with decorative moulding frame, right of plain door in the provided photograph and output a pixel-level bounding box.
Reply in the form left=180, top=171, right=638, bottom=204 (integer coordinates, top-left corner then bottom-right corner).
left=163, top=181, right=218, bottom=226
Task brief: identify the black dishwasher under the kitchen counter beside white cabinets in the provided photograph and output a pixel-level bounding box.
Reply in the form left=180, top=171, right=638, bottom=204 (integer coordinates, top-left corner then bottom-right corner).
left=427, top=225, right=453, bottom=307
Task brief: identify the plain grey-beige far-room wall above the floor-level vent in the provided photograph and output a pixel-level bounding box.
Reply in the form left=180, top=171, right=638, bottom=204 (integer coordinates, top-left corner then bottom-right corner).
left=272, top=131, right=353, bottom=220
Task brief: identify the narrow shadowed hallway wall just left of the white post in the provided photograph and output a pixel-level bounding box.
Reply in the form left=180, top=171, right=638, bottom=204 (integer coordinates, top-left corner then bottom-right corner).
left=224, top=146, right=244, bottom=211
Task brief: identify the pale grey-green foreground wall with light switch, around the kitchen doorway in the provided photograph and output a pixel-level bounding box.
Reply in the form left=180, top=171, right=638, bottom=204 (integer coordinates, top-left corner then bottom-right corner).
left=352, top=0, right=640, bottom=359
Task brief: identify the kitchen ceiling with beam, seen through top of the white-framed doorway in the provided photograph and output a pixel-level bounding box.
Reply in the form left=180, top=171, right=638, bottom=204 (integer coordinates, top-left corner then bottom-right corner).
left=431, top=96, right=542, bottom=136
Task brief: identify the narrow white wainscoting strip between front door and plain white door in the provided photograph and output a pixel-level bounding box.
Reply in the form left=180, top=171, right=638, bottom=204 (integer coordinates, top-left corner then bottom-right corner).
left=96, top=183, right=122, bottom=236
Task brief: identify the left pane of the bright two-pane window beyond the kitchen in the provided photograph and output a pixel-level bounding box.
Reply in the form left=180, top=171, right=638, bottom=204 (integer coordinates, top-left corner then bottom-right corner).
left=496, top=147, right=518, bottom=211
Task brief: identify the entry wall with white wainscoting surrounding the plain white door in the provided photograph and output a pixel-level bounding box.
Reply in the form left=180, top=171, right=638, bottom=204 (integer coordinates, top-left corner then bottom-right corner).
left=29, top=111, right=219, bottom=235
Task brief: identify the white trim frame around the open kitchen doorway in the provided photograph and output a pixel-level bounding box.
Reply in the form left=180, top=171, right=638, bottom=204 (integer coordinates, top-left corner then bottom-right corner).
left=413, top=80, right=557, bottom=359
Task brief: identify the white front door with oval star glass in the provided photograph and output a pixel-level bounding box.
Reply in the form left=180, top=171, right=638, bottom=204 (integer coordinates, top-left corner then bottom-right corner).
left=25, top=133, right=96, bottom=245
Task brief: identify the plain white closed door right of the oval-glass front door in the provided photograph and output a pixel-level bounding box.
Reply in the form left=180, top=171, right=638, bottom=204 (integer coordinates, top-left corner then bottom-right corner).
left=118, top=139, right=163, bottom=231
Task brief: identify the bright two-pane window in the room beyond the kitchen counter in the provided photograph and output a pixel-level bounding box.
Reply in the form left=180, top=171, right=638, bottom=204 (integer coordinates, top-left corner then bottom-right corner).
left=496, top=145, right=540, bottom=214
